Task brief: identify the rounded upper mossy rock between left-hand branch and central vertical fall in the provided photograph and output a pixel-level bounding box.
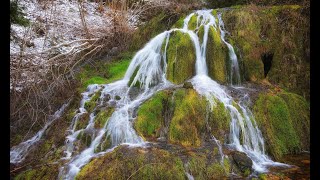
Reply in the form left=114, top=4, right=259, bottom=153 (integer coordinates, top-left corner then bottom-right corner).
left=167, top=31, right=196, bottom=84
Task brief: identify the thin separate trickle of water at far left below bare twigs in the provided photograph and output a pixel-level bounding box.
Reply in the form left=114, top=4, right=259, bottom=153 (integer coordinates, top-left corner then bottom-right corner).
left=10, top=100, right=70, bottom=164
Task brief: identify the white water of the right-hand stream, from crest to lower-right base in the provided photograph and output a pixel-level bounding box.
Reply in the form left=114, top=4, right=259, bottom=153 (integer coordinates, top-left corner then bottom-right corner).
left=184, top=10, right=285, bottom=172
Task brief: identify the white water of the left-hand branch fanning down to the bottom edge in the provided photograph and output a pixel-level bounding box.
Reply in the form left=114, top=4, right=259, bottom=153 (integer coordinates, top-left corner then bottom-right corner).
left=59, top=31, right=176, bottom=179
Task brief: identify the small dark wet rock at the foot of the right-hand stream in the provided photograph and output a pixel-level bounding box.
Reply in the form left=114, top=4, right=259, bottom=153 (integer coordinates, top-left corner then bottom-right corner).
left=232, top=151, right=252, bottom=173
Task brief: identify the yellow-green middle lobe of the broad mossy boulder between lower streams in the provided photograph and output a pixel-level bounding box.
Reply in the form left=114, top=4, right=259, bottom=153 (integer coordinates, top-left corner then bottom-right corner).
left=169, top=89, right=207, bottom=146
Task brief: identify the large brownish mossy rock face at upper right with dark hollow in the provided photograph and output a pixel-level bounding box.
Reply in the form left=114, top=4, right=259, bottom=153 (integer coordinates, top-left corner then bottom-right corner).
left=222, top=5, right=310, bottom=99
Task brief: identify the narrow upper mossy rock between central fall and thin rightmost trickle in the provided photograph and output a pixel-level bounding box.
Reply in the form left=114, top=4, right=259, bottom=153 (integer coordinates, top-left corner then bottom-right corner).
left=198, top=26, right=230, bottom=83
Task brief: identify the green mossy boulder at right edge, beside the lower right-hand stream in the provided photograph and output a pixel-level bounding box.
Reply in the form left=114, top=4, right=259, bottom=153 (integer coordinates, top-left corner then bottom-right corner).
left=253, top=92, right=310, bottom=160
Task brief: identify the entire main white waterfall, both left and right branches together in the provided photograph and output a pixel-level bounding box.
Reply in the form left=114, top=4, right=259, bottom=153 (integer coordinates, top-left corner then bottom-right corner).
left=10, top=7, right=292, bottom=179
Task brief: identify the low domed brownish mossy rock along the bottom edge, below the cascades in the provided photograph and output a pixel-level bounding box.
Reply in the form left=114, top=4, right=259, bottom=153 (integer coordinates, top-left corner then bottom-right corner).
left=76, top=146, right=185, bottom=180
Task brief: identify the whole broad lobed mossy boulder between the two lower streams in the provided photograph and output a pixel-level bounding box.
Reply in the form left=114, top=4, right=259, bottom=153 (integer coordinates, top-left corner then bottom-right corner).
left=134, top=88, right=231, bottom=147
